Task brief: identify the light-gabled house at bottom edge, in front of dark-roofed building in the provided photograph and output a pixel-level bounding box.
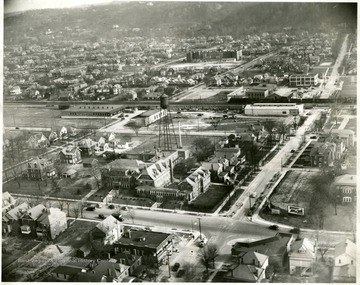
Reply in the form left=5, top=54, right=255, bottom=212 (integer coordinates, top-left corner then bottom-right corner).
left=224, top=251, right=269, bottom=283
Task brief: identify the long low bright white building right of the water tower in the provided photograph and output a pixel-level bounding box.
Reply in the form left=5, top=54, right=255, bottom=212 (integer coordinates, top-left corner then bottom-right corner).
left=245, top=103, right=304, bottom=116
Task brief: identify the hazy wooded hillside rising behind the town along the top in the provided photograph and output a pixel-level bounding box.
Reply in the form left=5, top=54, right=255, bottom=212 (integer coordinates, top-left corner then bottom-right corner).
left=4, top=2, right=357, bottom=36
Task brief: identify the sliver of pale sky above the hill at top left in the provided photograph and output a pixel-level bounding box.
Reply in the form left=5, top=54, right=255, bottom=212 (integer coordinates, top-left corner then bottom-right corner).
left=4, top=0, right=121, bottom=13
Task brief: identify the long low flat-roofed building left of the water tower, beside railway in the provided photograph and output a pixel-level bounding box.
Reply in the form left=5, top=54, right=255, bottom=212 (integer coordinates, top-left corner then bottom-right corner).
left=61, top=104, right=123, bottom=118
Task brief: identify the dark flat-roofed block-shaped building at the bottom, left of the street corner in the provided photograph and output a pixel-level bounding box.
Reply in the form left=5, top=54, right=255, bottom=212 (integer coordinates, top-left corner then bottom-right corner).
left=114, top=229, right=173, bottom=265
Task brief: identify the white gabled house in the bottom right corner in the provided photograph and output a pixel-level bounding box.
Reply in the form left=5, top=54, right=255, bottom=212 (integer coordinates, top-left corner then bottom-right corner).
left=332, top=239, right=357, bottom=283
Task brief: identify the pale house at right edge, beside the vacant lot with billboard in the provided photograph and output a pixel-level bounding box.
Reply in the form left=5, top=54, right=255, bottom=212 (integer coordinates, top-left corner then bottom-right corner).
left=333, top=174, right=356, bottom=204
